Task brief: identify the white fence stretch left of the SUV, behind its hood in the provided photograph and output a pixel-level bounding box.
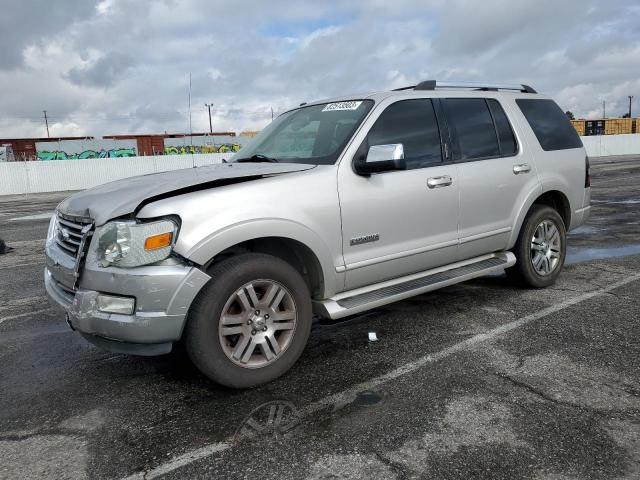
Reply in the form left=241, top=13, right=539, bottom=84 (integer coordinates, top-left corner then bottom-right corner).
left=0, top=153, right=232, bottom=195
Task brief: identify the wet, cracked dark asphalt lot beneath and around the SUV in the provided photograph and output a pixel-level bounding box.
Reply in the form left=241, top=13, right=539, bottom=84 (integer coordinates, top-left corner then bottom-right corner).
left=0, top=157, right=640, bottom=480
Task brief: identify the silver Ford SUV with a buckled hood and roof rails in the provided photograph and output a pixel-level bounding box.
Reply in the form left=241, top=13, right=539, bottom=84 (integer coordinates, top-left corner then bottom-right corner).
left=45, top=81, right=590, bottom=388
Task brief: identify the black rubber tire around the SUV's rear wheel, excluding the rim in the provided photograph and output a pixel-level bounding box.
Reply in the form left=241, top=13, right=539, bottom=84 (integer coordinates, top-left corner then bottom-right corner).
left=506, top=205, right=567, bottom=288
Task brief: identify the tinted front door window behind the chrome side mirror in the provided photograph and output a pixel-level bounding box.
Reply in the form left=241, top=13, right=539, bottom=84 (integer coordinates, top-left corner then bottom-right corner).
left=367, top=99, right=442, bottom=168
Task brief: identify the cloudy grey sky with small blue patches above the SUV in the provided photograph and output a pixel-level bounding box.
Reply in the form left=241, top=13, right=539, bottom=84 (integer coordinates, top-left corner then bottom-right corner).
left=0, top=0, right=640, bottom=138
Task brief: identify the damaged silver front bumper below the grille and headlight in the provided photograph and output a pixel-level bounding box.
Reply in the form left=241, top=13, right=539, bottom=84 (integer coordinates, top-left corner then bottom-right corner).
left=44, top=244, right=210, bottom=355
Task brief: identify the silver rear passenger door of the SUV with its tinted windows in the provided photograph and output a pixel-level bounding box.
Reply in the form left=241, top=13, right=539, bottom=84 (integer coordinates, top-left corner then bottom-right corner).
left=442, top=97, right=539, bottom=260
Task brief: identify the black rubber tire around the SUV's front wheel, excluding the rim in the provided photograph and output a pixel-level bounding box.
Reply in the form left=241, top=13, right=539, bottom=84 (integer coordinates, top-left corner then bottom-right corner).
left=183, top=253, right=312, bottom=388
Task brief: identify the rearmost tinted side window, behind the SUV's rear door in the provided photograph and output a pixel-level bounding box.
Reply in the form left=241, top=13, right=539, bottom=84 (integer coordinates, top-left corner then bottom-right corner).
left=516, top=99, right=582, bottom=150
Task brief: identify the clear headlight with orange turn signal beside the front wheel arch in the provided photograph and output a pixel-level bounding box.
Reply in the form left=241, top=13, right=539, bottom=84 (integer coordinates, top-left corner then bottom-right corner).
left=87, top=220, right=178, bottom=267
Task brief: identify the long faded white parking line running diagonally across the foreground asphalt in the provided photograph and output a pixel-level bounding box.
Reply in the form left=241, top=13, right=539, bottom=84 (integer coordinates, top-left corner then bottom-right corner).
left=123, top=273, right=640, bottom=480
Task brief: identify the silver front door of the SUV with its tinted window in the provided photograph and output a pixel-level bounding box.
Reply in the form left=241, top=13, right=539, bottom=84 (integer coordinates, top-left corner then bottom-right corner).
left=338, top=99, right=459, bottom=289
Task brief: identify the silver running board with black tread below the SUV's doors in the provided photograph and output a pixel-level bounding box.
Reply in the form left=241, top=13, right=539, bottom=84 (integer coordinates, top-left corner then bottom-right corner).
left=314, top=252, right=516, bottom=320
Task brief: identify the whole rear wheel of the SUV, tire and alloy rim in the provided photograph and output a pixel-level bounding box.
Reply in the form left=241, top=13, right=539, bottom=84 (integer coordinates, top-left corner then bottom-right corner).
left=507, top=205, right=567, bottom=288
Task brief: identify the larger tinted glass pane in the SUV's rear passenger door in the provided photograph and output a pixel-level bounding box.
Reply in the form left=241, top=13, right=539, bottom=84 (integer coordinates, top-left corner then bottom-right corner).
left=443, top=98, right=500, bottom=160
